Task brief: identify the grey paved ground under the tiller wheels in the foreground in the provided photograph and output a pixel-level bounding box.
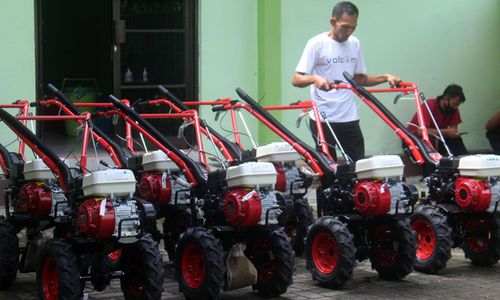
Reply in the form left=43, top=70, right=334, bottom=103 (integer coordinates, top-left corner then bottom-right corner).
left=0, top=249, right=500, bottom=300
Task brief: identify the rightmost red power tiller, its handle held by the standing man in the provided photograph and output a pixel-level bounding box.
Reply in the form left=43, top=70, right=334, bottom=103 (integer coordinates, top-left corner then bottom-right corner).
left=338, top=73, right=500, bottom=273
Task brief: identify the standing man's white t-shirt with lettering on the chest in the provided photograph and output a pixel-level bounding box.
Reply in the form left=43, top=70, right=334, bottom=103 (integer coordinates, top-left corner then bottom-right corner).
left=295, top=32, right=366, bottom=123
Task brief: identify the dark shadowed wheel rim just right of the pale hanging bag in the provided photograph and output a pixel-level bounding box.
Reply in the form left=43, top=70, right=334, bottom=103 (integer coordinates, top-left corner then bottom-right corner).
left=250, top=238, right=277, bottom=282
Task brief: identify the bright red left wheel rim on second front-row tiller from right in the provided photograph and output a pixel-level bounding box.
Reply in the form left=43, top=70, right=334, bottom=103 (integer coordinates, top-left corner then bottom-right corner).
left=311, top=232, right=339, bottom=274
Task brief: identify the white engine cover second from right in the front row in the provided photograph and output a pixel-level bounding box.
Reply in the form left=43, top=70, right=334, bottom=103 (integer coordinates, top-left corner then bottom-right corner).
left=356, top=155, right=404, bottom=179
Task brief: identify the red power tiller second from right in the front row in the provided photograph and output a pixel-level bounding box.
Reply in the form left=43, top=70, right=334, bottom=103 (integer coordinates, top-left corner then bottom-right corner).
left=227, top=89, right=416, bottom=287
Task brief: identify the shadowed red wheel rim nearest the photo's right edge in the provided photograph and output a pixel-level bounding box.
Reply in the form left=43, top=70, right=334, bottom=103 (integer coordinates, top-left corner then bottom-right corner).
left=464, top=217, right=491, bottom=253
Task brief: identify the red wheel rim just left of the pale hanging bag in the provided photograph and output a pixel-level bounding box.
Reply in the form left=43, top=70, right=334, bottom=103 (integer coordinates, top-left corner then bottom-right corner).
left=181, top=243, right=206, bottom=289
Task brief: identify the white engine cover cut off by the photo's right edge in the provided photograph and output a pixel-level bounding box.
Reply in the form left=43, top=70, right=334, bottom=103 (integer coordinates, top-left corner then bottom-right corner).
left=458, top=154, right=500, bottom=177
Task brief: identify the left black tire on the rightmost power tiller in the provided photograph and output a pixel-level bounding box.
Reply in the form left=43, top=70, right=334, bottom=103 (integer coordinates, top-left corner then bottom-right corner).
left=411, top=205, right=453, bottom=274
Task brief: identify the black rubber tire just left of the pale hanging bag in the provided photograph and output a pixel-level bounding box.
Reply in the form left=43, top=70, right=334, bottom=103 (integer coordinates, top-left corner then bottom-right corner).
left=175, top=227, right=226, bottom=300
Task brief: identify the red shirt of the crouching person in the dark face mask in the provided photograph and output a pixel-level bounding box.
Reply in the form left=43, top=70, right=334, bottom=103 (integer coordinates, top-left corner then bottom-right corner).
left=407, top=98, right=462, bottom=133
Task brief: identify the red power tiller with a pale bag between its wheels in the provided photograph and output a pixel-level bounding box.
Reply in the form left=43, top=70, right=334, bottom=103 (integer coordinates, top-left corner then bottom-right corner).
left=68, top=96, right=293, bottom=299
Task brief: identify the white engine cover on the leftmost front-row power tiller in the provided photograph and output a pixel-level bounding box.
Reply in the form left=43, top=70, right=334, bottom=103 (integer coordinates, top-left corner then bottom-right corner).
left=82, top=169, right=136, bottom=197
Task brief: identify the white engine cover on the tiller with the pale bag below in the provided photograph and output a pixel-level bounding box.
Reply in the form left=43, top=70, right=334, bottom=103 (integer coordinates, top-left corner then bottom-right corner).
left=226, top=162, right=278, bottom=188
